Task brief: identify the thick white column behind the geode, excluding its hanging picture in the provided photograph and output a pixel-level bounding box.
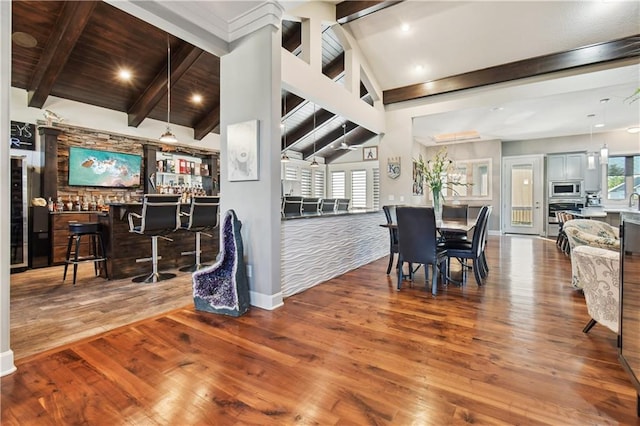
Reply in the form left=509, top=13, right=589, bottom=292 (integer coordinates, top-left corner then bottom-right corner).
left=220, top=26, right=282, bottom=309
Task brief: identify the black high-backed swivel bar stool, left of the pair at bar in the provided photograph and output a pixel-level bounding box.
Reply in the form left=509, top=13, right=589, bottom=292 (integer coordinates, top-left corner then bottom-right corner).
left=128, top=194, right=181, bottom=283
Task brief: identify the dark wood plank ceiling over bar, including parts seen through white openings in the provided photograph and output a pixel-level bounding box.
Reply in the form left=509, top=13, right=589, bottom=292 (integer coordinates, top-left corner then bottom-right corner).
left=11, top=1, right=376, bottom=163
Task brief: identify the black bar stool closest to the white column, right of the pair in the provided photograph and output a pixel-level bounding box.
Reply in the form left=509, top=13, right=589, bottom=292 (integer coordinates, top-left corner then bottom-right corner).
left=180, top=196, right=220, bottom=272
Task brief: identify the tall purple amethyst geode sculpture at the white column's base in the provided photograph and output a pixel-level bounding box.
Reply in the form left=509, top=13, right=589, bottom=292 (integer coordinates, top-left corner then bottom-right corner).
left=193, top=210, right=249, bottom=317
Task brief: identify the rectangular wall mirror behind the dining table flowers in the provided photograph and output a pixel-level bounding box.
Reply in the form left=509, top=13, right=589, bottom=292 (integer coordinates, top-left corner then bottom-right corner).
left=444, top=158, right=491, bottom=200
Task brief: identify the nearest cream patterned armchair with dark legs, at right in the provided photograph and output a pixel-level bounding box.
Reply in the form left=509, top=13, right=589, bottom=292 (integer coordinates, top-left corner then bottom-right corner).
left=571, top=246, right=620, bottom=333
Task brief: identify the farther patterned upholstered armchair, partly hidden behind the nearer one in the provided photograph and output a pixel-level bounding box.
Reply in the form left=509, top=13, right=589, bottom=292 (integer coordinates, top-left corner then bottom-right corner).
left=562, top=219, right=620, bottom=288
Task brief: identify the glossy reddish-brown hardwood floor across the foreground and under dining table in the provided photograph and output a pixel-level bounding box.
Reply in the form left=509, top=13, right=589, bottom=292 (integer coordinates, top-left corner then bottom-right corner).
left=0, top=236, right=640, bottom=425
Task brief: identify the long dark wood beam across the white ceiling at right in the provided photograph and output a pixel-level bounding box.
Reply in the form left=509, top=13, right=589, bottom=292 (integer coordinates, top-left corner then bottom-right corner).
left=383, top=35, right=640, bottom=105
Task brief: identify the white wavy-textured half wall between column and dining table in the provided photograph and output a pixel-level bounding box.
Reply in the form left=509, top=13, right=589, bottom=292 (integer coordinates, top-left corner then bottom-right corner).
left=280, top=210, right=389, bottom=297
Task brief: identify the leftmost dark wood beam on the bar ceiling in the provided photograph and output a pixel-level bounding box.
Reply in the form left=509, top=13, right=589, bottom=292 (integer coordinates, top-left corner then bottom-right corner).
left=28, top=1, right=98, bottom=108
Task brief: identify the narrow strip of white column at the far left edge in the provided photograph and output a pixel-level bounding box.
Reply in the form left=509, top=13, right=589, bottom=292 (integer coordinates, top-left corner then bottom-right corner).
left=0, top=1, right=16, bottom=376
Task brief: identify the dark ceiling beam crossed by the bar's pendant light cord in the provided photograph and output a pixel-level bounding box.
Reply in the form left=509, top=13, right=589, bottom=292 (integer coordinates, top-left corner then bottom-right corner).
left=127, top=44, right=204, bottom=127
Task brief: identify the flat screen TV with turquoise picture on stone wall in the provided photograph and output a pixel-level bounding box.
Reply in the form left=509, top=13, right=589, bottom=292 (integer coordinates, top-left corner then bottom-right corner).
left=69, top=146, right=142, bottom=188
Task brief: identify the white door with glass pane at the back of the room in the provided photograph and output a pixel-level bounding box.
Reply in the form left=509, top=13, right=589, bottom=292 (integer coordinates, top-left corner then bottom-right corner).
left=501, top=155, right=544, bottom=235
